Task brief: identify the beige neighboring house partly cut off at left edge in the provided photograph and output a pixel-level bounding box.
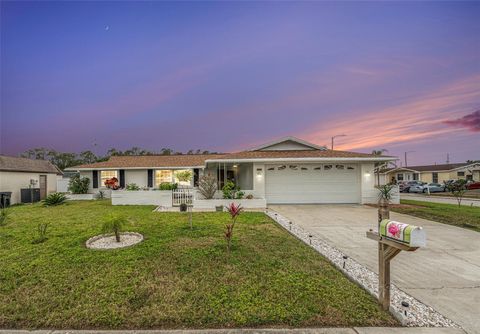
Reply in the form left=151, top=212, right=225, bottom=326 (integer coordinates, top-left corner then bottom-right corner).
left=0, top=155, right=62, bottom=204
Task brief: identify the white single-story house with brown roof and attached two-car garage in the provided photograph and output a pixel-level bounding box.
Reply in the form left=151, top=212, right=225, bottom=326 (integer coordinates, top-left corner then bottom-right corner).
left=67, top=137, right=395, bottom=204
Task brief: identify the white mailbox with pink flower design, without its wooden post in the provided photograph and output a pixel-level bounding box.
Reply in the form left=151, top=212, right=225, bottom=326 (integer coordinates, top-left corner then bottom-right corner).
left=379, top=219, right=427, bottom=247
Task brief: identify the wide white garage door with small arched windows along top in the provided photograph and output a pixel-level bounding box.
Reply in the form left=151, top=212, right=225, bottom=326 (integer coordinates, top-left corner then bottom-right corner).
left=265, top=164, right=360, bottom=204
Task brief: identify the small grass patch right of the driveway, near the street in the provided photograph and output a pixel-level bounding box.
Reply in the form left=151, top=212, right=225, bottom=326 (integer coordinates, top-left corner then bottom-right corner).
left=390, top=199, right=480, bottom=232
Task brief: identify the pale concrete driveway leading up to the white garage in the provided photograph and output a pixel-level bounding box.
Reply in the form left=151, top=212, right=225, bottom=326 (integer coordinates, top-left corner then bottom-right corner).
left=269, top=205, right=480, bottom=334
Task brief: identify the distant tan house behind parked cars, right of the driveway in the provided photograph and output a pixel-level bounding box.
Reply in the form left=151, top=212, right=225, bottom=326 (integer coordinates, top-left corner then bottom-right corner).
left=380, top=163, right=480, bottom=184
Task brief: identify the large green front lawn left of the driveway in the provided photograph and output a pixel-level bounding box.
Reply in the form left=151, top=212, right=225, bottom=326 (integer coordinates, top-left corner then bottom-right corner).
left=0, top=201, right=398, bottom=329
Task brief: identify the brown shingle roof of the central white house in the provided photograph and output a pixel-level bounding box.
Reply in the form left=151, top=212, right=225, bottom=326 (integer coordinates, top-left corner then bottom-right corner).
left=67, top=150, right=393, bottom=170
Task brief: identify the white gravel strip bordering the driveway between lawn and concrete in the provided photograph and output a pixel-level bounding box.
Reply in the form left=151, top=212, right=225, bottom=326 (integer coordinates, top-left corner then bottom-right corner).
left=265, top=210, right=460, bottom=328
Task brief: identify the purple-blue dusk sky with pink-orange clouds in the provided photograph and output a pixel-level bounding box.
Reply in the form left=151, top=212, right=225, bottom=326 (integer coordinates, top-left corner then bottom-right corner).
left=0, top=1, right=480, bottom=165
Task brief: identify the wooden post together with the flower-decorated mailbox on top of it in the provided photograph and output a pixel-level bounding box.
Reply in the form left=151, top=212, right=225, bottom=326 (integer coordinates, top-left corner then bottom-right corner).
left=367, top=219, right=426, bottom=310
